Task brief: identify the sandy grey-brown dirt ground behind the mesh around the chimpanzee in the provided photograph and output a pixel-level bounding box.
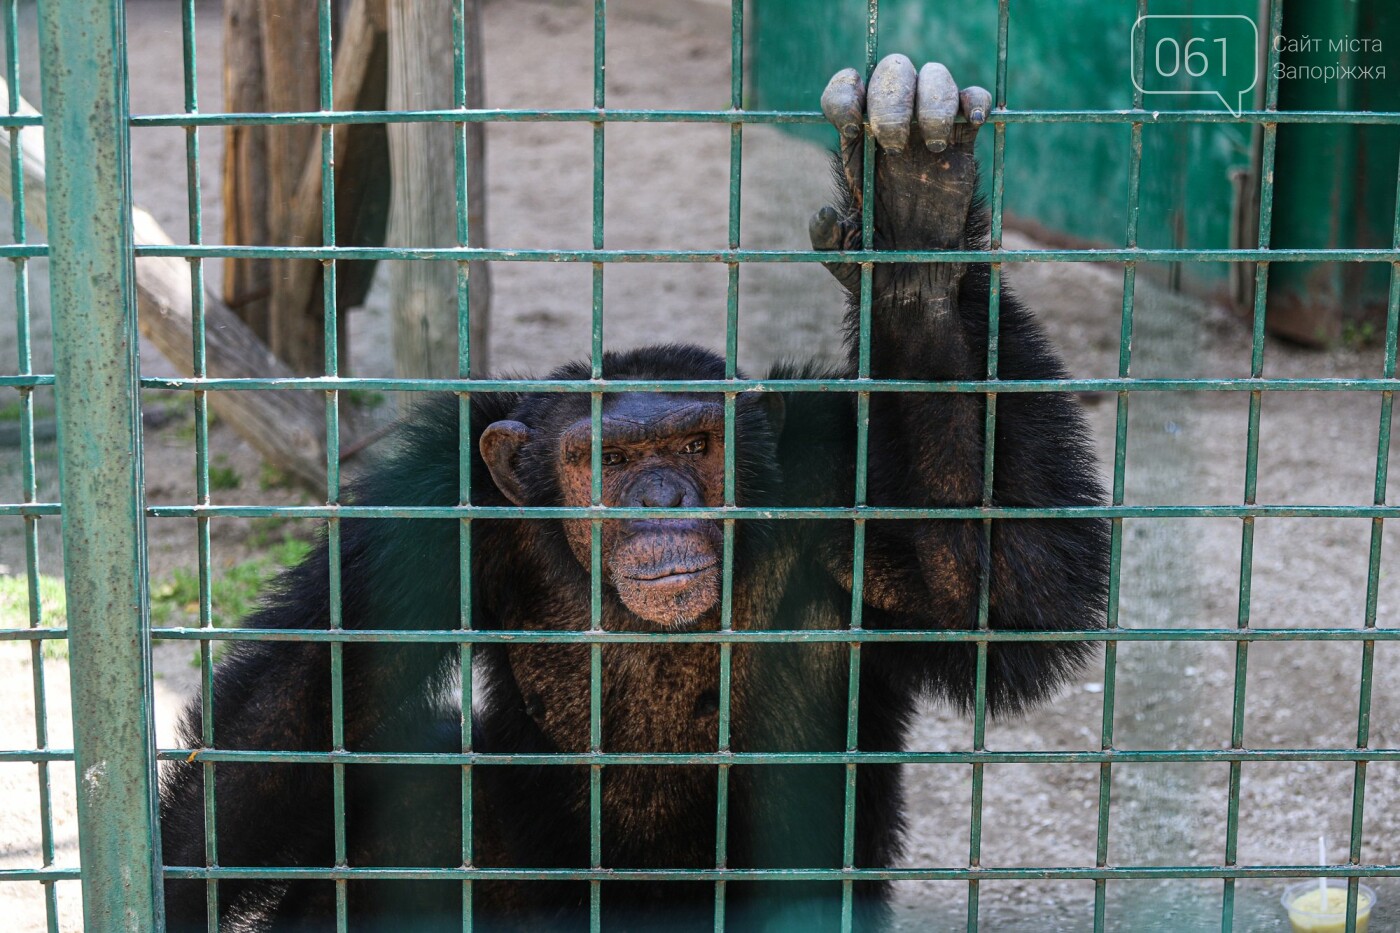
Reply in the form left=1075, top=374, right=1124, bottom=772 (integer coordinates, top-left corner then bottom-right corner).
left=0, top=0, right=1400, bottom=933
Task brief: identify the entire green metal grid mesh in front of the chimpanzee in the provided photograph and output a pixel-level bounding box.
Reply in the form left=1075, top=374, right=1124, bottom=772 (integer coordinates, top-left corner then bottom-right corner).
left=0, top=0, right=1400, bottom=930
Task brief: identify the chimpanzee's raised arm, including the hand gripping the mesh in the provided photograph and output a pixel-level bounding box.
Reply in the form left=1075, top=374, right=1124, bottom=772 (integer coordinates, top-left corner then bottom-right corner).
left=784, top=55, right=1107, bottom=709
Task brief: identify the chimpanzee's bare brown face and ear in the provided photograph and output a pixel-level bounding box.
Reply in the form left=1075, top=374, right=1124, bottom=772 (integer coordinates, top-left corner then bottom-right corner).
left=482, top=394, right=724, bottom=628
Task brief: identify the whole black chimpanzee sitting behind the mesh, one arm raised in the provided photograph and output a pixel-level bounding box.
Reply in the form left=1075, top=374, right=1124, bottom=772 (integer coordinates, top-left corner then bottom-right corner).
left=161, top=55, right=1109, bottom=930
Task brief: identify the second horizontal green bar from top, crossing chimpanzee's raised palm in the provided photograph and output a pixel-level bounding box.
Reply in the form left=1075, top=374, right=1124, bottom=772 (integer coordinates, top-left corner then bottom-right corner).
left=133, top=244, right=1400, bottom=263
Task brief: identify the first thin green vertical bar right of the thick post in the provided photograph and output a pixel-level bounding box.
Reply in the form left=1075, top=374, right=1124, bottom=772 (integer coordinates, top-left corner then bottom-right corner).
left=181, top=0, right=218, bottom=933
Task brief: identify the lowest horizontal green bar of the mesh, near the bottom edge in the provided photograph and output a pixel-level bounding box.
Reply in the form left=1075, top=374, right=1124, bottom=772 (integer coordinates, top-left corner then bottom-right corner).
left=158, top=864, right=1400, bottom=881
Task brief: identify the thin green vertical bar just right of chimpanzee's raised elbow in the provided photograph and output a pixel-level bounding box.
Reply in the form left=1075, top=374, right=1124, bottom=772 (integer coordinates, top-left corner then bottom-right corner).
left=1093, top=0, right=1147, bottom=933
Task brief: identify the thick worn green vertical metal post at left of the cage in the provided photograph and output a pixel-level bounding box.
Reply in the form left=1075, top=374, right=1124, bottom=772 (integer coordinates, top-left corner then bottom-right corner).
left=39, top=0, right=161, bottom=933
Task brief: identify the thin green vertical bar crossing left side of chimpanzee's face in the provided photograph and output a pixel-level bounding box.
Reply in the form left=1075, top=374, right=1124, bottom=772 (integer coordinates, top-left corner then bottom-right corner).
left=588, top=0, right=608, bottom=933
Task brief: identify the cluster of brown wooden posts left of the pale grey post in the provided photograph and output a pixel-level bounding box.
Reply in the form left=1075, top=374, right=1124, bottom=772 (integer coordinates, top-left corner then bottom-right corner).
left=224, top=0, right=389, bottom=374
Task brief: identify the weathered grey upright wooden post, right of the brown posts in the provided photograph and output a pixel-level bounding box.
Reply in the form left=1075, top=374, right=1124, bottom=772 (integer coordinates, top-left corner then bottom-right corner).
left=389, top=0, right=490, bottom=377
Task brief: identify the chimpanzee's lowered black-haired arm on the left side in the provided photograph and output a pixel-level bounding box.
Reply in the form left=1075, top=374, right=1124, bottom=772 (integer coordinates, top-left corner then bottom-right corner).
left=161, top=396, right=508, bottom=930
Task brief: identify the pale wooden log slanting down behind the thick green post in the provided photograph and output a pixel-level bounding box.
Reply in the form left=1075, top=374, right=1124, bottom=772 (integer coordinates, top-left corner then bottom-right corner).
left=0, top=78, right=350, bottom=493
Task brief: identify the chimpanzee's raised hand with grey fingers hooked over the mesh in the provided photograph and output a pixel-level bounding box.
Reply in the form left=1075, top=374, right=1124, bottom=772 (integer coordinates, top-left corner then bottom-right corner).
left=809, top=55, right=991, bottom=291
